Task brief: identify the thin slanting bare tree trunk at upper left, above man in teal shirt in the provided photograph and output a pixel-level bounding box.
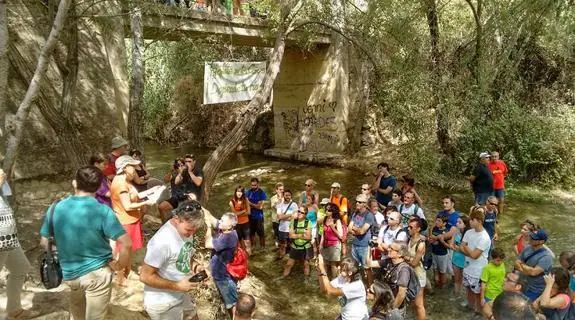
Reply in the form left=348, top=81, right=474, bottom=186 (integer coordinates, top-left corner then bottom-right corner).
left=3, top=0, right=70, bottom=178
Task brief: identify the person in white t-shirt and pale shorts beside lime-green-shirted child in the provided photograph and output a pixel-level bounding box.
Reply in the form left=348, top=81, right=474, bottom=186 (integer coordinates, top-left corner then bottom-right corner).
left=454, top=208, right=491, bottom=312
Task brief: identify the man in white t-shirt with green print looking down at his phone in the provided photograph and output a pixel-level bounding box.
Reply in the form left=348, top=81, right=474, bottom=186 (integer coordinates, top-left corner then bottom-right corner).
left=140, top=201, right=204, bottom=320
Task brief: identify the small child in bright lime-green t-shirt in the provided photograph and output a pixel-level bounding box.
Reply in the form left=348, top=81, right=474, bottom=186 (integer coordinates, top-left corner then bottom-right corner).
left=480, top=248, right=505, bottom=314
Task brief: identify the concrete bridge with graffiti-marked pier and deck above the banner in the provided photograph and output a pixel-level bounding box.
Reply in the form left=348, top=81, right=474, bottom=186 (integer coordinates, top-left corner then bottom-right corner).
left=124, top=6, right=349, bottom=161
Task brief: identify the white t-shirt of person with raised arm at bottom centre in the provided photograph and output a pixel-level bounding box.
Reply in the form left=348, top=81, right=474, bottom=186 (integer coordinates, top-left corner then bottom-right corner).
left=331, top=276, right=369, bottom=320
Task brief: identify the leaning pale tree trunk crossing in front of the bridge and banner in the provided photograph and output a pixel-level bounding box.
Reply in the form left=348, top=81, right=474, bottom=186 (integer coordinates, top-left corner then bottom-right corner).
left=201, top=1, right=301, bottom=205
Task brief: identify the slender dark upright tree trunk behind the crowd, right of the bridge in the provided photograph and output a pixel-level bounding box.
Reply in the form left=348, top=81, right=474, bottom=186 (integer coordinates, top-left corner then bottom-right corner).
left=426, top=0, right=452, bottom=157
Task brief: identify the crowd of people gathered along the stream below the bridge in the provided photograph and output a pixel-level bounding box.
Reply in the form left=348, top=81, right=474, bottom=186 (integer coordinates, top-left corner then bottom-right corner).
left=0, top=137, right=575, bottom=320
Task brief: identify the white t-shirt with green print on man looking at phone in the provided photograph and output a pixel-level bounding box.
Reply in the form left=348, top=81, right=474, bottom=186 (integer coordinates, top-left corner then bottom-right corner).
left=144, top=221, right=195, bottom=306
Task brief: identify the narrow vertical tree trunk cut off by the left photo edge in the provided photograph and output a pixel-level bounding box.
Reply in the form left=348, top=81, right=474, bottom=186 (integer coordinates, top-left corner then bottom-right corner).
left=0, top=0, right=10, bottom=159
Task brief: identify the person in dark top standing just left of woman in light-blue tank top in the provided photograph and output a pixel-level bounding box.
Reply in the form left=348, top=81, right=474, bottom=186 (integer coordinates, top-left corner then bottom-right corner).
left=429, top=215, right=451, bottom=288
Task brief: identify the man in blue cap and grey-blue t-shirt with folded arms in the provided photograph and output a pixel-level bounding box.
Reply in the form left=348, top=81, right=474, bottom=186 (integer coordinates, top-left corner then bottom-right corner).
left=515, top=228, right=553, bottom=301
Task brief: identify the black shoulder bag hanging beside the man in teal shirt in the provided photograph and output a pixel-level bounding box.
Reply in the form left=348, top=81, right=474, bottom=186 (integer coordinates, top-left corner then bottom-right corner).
left=40, top=201, right=63, bottom=289
